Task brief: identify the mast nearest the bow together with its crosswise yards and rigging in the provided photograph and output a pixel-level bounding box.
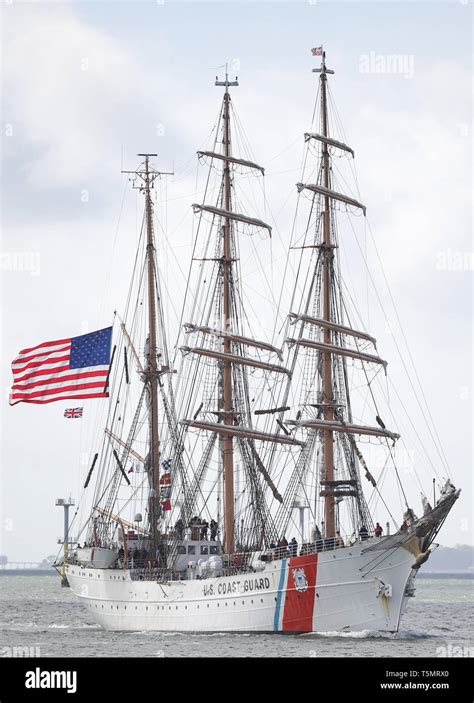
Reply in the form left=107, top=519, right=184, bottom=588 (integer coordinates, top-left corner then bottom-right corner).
left=285, top=52, right=398, bottom=538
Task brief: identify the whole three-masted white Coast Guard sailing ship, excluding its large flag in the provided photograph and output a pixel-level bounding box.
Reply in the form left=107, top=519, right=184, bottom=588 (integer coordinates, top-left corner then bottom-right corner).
left=50, top=52, right=459, bottom=632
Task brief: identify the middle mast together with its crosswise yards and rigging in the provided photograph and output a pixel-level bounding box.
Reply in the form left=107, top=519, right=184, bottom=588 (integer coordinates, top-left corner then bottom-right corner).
left=180, top=70, right=284, bottom=554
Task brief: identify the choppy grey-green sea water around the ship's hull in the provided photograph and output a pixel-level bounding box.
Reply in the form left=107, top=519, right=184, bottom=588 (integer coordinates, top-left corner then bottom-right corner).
left=0, top=575, right=474, bottom=657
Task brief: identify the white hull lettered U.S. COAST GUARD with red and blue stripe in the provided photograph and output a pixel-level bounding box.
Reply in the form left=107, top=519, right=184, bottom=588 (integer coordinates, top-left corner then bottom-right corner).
left=66, top=539, right=415, bottom=632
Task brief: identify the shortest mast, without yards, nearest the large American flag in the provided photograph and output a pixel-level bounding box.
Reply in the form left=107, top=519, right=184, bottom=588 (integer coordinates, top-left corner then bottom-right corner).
left=124, top=154, right=172, bottom=543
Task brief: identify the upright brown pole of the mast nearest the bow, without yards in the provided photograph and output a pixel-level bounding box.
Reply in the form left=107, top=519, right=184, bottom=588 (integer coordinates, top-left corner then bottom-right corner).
left=320, top=52, right=336, bottom=537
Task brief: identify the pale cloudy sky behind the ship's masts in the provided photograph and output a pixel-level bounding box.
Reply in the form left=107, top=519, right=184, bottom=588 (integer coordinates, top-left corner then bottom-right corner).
left=0, top=0, right=473, bottom=560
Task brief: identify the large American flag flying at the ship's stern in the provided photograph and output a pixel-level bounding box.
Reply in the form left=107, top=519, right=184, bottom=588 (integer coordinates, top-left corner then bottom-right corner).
left=10, top=327, right=112, bottom=405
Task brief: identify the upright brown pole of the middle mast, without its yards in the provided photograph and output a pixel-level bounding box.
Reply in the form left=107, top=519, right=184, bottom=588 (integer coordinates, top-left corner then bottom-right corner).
left=215, top=67, right=239, bottom=554
